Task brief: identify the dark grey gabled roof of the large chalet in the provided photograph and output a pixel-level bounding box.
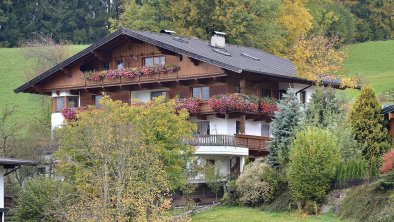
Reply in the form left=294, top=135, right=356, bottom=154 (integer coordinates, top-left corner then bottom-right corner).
left=14, top=29, right=298, bottom=93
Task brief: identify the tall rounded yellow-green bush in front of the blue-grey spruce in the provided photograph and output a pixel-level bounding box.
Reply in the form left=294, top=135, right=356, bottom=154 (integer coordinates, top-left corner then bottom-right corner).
left=287, top=128, right=339, bottom=208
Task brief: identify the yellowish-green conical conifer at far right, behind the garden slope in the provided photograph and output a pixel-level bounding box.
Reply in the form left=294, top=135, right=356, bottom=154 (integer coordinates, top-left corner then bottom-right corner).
left=349, top=86, right=390, bottom=161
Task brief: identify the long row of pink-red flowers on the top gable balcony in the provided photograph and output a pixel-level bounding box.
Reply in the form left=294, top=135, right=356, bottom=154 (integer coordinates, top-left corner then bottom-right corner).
left=83, top=65, right=180, bottom=81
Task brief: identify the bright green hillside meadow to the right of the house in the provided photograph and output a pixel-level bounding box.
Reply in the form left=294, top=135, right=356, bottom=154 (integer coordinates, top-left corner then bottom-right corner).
left=345, top=40, right=394, bottom=94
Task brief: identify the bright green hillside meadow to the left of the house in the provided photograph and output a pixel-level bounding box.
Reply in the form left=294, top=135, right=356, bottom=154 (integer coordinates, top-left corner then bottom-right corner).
left=0, top=46, right=86, bottom=125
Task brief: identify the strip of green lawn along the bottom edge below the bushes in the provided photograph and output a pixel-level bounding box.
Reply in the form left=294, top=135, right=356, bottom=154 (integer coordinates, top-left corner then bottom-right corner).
left=192, top=207, right=340, bottom=222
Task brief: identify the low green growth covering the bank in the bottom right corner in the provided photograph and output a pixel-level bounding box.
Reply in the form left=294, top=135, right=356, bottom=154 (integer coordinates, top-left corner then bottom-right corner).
left=338, top=184, right=394, bottom=222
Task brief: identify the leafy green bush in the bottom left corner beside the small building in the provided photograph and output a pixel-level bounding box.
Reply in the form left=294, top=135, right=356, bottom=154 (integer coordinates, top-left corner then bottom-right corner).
left=15, top=177, right=76, bottom=221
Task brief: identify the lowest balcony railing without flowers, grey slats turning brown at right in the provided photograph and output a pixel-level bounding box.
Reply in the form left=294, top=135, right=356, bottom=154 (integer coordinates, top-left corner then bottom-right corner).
left=185, top=134, right=270, bottom=152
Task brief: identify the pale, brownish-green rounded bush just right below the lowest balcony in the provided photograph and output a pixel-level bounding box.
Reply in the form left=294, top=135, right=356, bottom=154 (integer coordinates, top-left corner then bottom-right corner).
left=236, top=159, right=279, bottom=206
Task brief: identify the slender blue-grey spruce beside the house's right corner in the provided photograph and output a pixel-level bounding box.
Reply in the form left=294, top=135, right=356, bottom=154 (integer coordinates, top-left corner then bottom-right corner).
left=268, top=89, right=303, bottom=168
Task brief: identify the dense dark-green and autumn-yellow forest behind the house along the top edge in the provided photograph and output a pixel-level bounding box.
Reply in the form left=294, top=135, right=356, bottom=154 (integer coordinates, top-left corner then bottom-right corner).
left=0, top=0, right=394, bottom=47
